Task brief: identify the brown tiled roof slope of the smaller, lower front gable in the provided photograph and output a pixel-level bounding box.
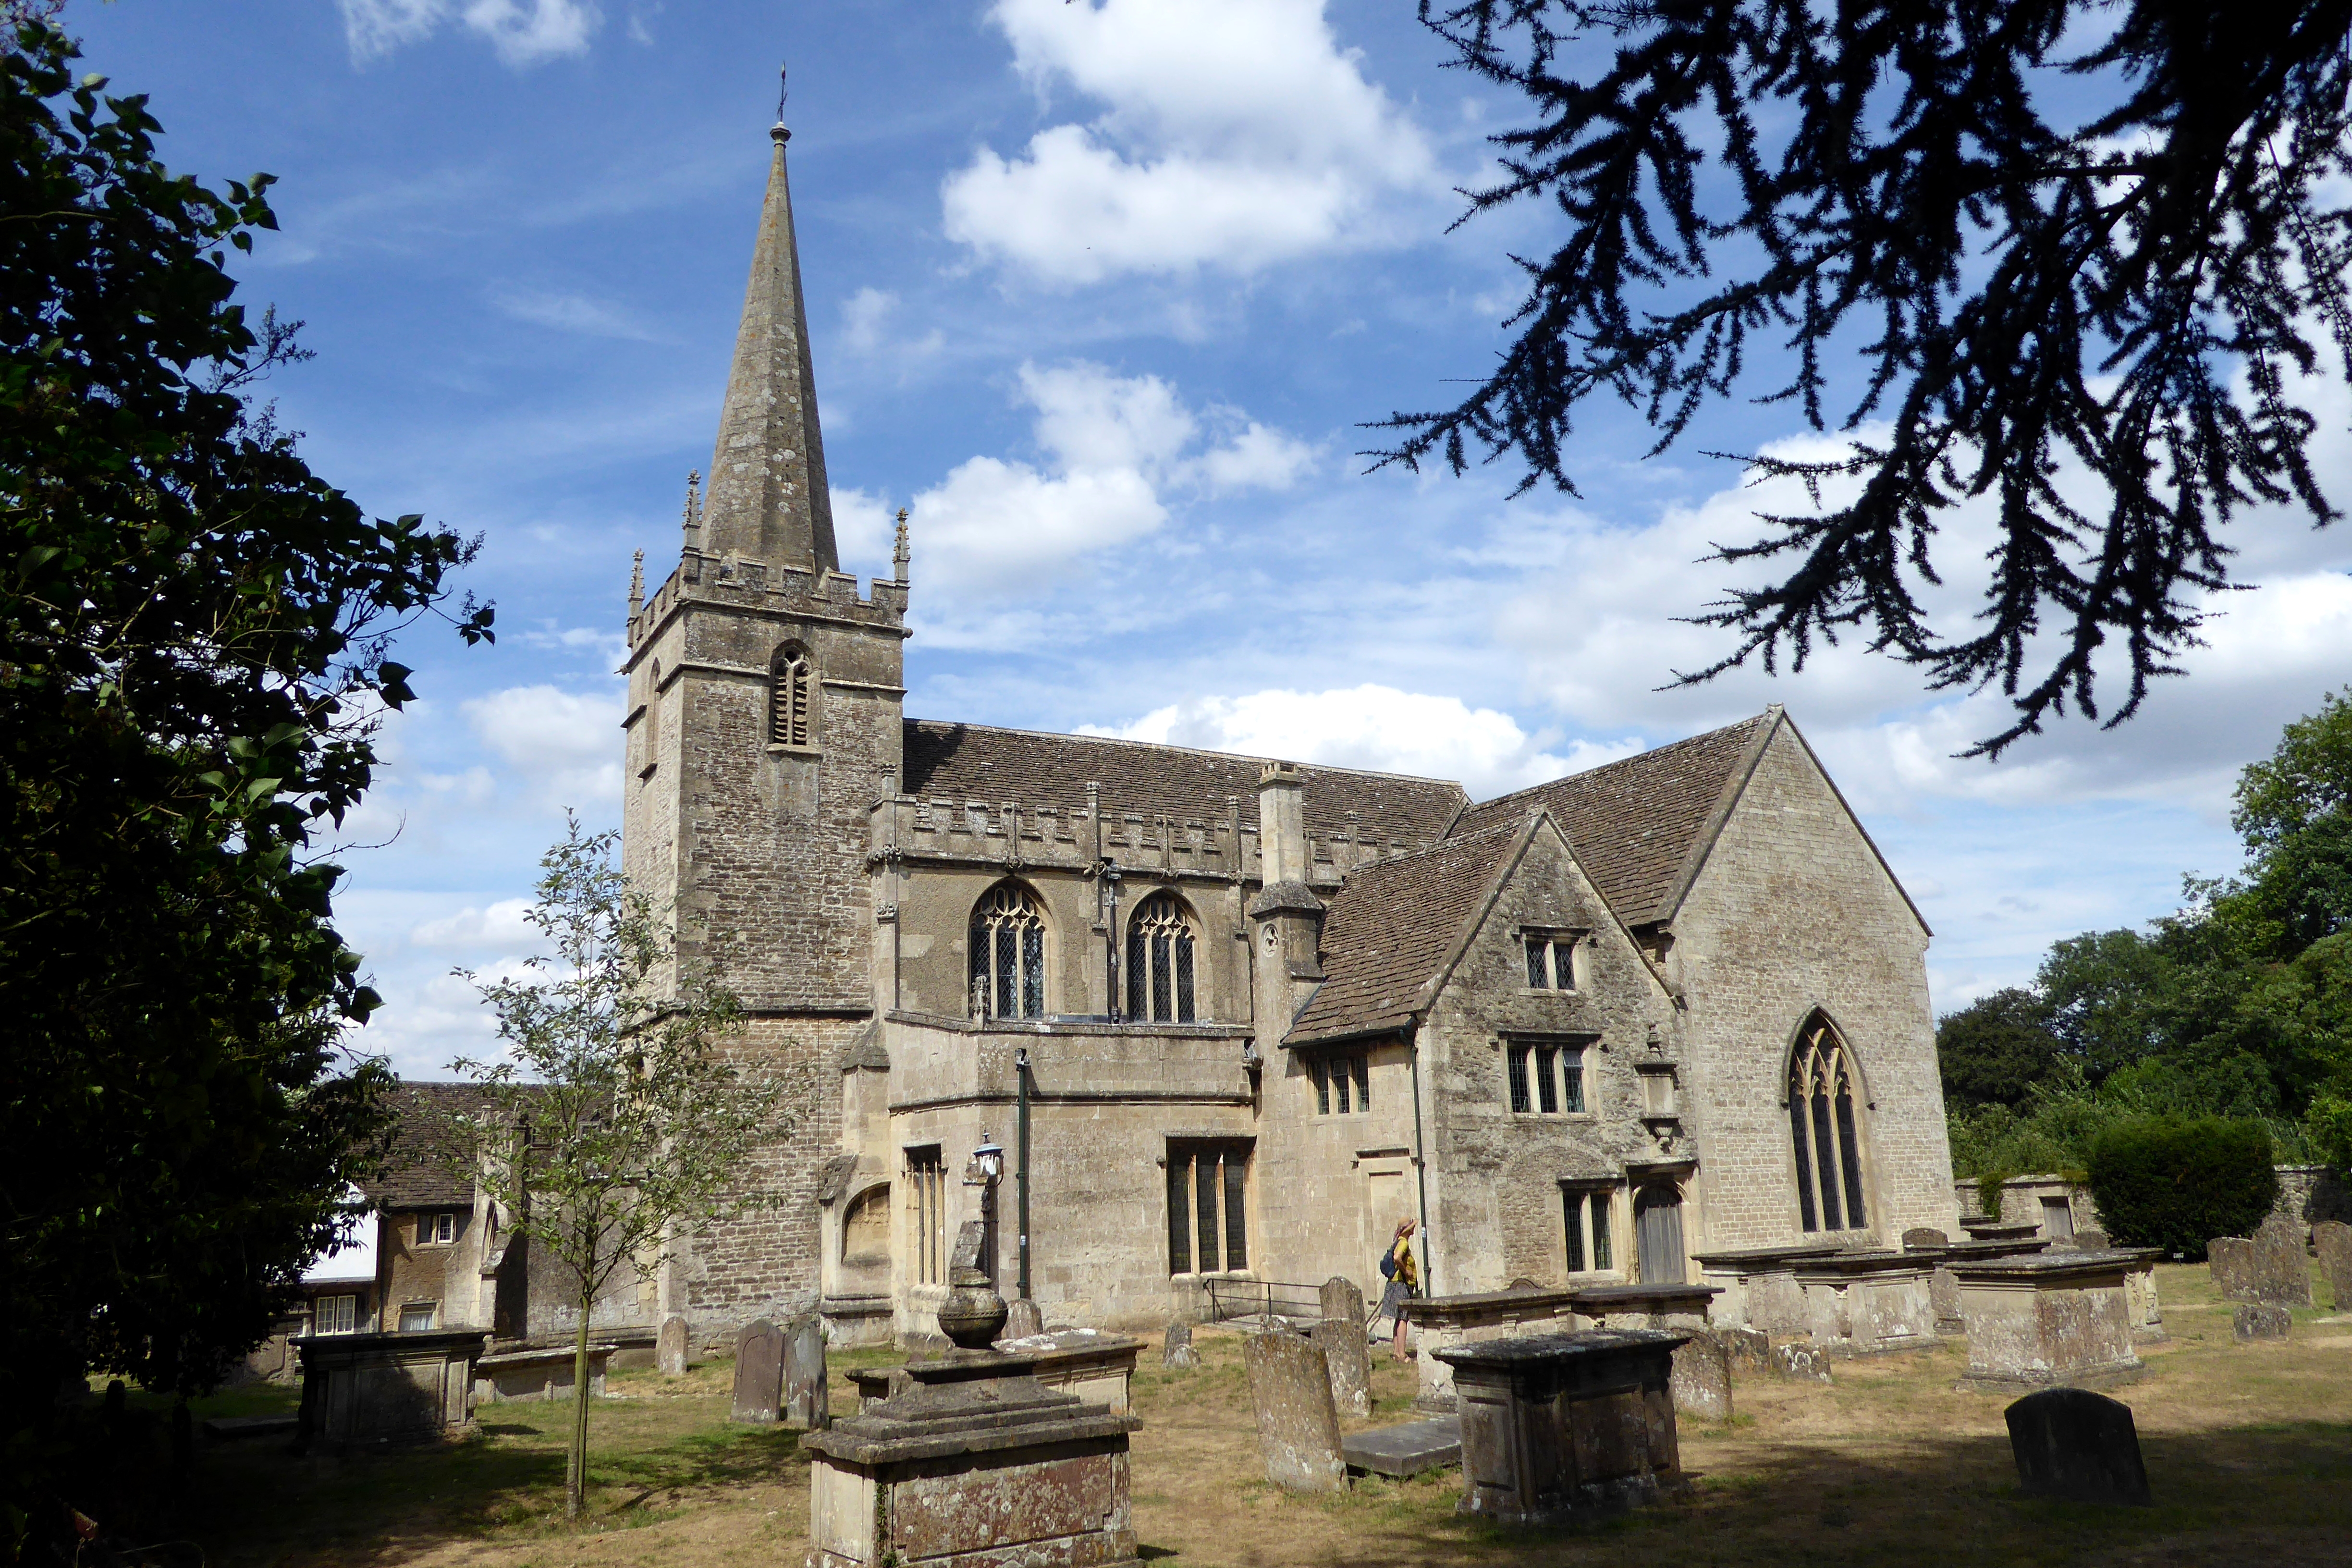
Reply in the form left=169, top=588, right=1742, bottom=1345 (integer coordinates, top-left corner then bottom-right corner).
left=1286, top=818, right=1524, bottom=1044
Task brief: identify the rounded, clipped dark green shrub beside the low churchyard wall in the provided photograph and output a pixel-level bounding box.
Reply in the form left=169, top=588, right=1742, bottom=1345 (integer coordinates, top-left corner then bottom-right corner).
left=2091, top=1116, right=2279, bottom=1260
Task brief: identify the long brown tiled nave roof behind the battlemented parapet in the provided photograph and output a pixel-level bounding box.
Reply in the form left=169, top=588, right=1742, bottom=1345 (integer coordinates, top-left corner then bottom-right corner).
left=901, top=719, right=1470, bottom=849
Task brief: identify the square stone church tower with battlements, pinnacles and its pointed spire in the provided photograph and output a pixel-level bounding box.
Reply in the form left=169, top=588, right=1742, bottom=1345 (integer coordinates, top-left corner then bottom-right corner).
left=621, top=124, right=908, bottom=1323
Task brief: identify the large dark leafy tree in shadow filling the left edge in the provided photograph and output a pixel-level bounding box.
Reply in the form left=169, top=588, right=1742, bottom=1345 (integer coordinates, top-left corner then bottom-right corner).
left=0, top=21, right=491, bottom=1533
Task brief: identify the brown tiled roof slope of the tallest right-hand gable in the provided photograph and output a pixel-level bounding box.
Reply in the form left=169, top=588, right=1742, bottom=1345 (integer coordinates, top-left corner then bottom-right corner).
left=1454, top=710, right=1778, bottom=926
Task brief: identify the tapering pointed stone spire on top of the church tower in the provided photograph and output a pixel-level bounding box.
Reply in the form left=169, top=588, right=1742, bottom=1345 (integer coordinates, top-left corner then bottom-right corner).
left=701, top=110, right=842, bottom=571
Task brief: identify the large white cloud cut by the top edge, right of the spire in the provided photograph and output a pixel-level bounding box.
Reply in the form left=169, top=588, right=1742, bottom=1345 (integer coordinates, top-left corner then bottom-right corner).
left=941, top=0, right=1446, bottom=284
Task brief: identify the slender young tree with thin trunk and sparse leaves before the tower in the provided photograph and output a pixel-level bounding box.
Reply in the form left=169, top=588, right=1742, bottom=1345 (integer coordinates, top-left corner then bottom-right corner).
left=452, top=818, right=809, bottom=1516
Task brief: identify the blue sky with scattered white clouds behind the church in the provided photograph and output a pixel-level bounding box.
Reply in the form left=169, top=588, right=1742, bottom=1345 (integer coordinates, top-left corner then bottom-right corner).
left=66, top=0, right=2352, bottom=1074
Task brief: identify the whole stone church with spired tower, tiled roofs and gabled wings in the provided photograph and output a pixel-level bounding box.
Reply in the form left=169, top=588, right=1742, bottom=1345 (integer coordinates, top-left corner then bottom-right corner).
left=623, top=124, right=1957, bottom=1340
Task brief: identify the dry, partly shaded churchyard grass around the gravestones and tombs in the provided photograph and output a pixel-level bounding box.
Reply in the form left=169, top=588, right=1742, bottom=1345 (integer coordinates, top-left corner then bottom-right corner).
left=156, top=1267, right=2352, bottom=1568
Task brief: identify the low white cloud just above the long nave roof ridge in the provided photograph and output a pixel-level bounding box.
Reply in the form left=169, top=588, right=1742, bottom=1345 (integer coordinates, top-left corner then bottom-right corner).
left=1079, top=684, right=1640, bottom=799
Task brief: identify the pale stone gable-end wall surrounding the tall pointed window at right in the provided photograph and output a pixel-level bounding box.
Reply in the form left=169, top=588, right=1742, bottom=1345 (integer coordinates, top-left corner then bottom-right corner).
left=1667, top=724, right=1957, bottom=1248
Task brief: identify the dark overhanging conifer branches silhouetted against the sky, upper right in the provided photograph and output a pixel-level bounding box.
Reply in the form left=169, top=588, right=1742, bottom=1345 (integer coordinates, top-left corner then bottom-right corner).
left=1378, top=0, right=2352, bottom=752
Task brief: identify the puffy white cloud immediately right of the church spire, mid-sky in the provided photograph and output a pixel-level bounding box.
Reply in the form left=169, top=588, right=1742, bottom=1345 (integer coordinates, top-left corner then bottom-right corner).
left=865, top=362, right=1315, bottom=613
